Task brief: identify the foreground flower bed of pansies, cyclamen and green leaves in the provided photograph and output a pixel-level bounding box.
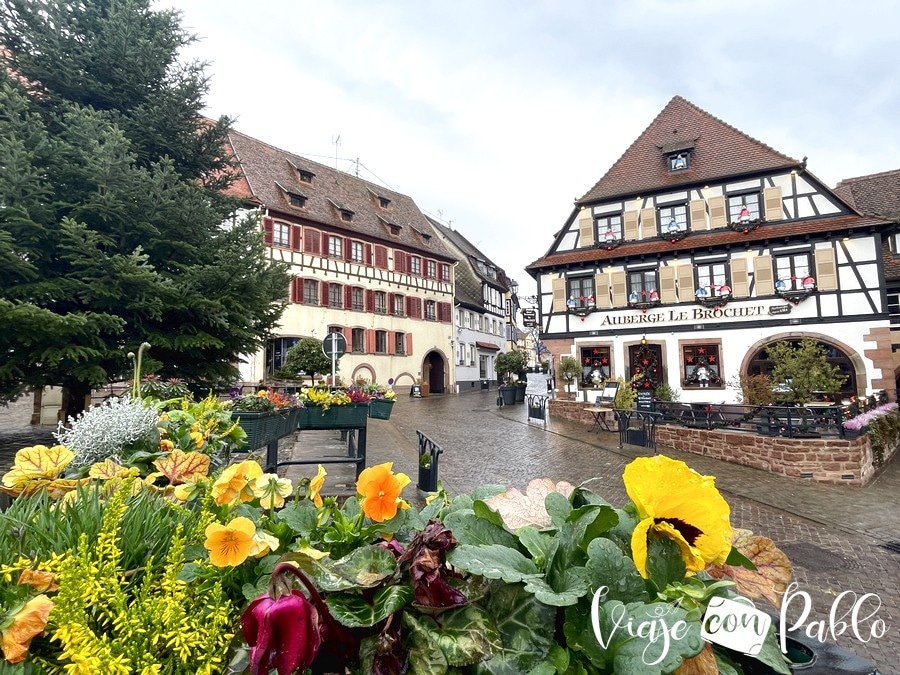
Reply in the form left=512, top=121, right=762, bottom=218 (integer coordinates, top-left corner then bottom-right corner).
left=0, top=436, right=804, bottom=674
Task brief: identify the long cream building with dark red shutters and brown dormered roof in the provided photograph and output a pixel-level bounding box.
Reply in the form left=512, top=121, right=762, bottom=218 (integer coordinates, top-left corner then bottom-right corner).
left=221, top=131, right=455, bottom=393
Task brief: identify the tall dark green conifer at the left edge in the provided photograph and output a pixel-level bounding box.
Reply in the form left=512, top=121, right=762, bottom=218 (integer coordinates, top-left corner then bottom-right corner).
left=0, top=0, right=288, bottom=414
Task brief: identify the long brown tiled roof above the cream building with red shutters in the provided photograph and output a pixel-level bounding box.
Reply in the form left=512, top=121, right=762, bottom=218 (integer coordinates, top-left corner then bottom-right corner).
left=222, top=131, right=455, bottom=261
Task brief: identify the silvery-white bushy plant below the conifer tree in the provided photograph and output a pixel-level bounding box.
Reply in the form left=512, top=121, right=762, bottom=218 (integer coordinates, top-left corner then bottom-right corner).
left=53, top=397, right=159, bottom=467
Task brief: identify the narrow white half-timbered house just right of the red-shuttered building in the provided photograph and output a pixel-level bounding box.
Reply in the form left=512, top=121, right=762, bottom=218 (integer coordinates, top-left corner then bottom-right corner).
left=429, top=218, right=510, bottom=393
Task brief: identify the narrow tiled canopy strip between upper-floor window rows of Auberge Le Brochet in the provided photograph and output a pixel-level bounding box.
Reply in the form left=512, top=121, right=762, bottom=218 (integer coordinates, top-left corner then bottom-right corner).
left=525, top=215, right=889, bottom=272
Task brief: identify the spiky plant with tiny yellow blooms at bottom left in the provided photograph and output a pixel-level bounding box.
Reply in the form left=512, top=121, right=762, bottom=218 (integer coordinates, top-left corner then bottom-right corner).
left=43, top=485, right=234, bottom=673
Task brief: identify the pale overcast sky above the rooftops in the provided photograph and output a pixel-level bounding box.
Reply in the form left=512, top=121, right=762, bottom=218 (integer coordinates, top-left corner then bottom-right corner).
left=171, top=0, right=900, bottom=295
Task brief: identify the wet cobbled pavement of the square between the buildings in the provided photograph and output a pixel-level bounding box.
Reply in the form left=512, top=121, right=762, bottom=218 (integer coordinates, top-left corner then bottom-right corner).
left=0, top=386, right=900, bottom=674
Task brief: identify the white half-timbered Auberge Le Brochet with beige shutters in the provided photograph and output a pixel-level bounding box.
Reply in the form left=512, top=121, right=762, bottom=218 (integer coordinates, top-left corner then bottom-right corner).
left=528, top=96, right=896, bottom=402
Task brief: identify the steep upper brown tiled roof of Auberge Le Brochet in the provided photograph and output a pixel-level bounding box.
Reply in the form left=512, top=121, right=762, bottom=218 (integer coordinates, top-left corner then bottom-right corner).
left=578, top=96, right=800, bottom=204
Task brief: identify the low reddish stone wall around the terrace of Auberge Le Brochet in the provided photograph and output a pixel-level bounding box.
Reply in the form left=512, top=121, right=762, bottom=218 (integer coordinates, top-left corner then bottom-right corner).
left=656, top=424, right=898, bottom=486
